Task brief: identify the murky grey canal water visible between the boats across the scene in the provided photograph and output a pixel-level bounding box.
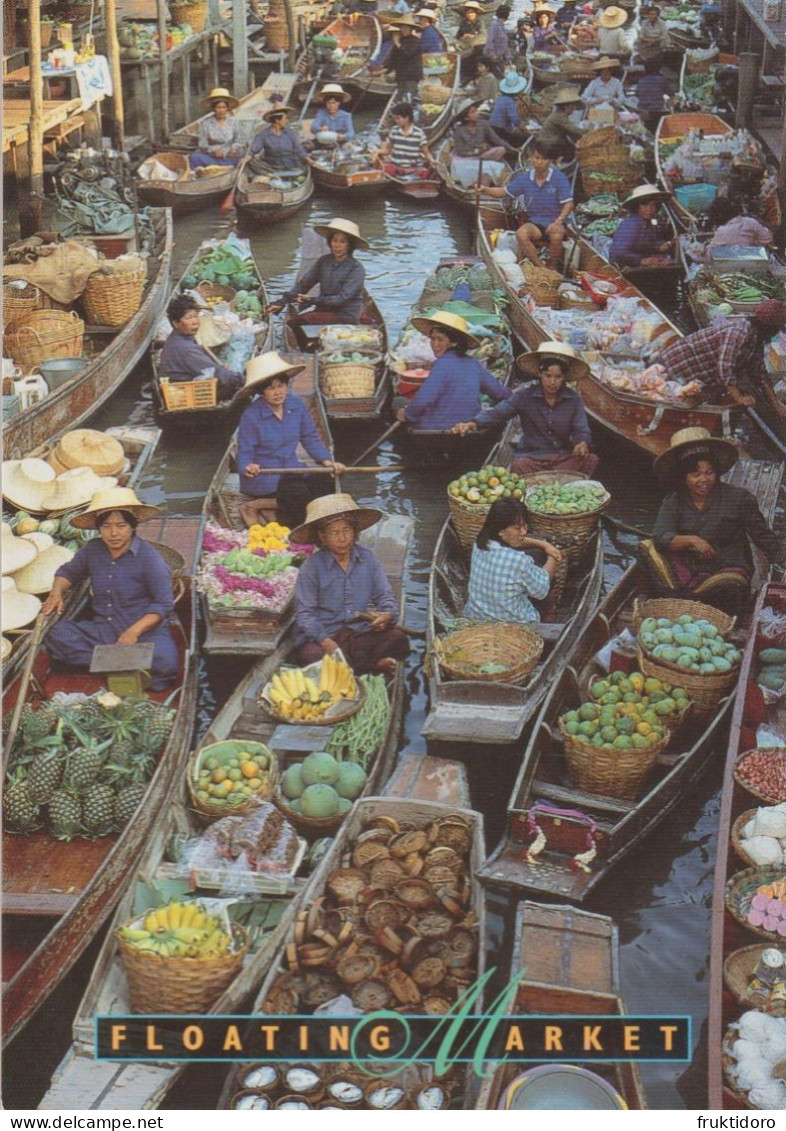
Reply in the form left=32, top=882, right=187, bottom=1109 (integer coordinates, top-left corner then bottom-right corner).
left=3, top=180, right=774, bottom=1108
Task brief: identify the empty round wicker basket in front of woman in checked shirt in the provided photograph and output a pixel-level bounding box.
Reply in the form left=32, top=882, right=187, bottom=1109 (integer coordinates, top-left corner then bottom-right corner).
left=434, top=622, right=543, bottom=683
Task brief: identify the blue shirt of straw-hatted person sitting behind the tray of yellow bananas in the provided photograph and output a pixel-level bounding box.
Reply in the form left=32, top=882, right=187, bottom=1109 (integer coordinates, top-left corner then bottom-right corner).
left=294, top=545, right=398, bottom=645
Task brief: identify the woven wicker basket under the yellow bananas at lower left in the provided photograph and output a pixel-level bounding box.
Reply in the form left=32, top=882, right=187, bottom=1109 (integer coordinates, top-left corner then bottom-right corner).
left=118, top=920, right=249, bottom=1013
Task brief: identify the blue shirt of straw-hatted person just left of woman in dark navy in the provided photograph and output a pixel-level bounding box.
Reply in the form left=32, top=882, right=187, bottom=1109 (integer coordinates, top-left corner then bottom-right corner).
left=406, top=349, right=511, bottom=430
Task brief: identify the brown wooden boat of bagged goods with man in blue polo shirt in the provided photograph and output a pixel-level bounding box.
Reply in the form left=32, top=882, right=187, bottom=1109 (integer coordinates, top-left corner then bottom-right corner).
left=478, top=208, right=740, bottom=456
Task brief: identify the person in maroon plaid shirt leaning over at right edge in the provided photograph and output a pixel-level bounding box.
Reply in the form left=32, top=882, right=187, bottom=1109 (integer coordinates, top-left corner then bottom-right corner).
left=655, top=299, right=786, bottom=418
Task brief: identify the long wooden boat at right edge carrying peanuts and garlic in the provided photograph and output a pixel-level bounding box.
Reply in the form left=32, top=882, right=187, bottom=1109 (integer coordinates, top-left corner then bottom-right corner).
left=708, top=581, right=786, bottom=1111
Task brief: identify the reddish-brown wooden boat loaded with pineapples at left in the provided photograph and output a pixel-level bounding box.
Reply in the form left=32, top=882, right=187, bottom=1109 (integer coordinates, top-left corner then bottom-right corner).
left=2, top=560, right=197, bottom=1042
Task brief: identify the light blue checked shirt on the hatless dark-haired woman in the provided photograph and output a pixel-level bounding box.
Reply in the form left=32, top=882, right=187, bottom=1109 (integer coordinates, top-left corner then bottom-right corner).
left=464, top=542, right=549, bottom=624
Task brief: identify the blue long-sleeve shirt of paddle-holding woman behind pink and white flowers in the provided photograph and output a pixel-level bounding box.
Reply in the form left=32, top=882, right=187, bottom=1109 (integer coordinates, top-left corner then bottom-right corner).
left=237, top=392, right=330, bottom=499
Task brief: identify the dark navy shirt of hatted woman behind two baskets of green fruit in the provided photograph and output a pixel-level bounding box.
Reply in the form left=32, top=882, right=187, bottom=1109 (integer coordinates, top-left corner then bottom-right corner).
left=473, top=381, right=593, bottom=458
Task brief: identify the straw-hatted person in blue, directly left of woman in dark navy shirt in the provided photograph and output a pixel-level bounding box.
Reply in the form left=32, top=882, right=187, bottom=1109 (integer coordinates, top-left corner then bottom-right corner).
left=396, top=310, right=511, bottom=432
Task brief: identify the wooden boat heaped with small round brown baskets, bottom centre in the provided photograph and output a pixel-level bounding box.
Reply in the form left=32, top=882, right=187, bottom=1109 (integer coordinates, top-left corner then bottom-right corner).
left=218, top=796, right=485, bottom=1110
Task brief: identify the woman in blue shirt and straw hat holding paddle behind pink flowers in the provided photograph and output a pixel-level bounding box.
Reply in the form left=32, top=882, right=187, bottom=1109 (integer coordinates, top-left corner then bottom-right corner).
left=237, top=349, right=346, bottom=526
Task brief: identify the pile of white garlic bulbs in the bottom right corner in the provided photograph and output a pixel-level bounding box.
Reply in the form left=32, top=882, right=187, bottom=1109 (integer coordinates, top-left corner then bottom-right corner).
left=726, top=1009, right=786, bottom=1111
